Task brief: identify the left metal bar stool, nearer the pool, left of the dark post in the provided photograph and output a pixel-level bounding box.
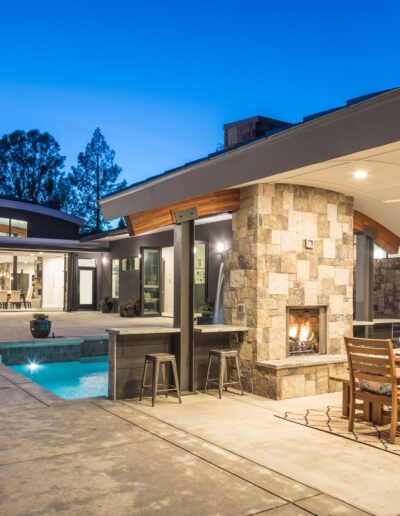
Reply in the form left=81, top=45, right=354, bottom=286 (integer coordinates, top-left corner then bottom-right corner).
left=140, top=353, right=182, bottom=407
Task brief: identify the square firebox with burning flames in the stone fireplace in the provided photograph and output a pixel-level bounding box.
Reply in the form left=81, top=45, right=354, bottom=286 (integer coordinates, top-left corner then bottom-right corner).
left=286, top=306, right=327, bottom=356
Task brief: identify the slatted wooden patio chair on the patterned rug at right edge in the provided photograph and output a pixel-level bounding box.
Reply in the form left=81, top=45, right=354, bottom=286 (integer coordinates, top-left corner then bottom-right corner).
left=345, top=337, right=399, bottom=443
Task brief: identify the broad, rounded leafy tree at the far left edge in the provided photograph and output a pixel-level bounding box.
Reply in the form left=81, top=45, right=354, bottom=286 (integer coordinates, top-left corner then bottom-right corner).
left=0, top=129, right=68, bottom=208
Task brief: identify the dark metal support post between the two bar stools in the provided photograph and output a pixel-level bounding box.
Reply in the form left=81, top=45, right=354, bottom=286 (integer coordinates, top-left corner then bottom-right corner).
left=179, top=220, right=194, bottom=392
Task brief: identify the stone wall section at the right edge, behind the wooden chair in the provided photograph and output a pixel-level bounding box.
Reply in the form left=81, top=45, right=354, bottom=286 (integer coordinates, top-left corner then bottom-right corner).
left=373, top=258, right=400, bottom=319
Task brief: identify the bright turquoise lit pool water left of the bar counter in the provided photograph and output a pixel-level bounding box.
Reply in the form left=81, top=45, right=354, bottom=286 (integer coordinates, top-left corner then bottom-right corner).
left=9, top=356, right=108, bottom=400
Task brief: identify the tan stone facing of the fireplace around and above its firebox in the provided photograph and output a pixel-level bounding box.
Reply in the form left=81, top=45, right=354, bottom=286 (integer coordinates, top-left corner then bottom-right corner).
left=224, top=184, right=353, bottom=391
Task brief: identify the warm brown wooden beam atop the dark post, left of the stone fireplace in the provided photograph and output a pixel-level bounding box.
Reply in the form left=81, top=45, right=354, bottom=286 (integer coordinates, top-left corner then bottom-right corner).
left=125, top=188, right=240, bottom=235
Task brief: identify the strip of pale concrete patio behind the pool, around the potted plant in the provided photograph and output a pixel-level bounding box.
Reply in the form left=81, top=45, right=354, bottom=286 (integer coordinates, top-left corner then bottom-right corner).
left=0, top=310, right=172, bottom=342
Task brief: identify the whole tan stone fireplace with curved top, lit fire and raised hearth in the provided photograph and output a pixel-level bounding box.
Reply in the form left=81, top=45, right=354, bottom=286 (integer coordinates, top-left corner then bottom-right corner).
left=224, top=184, right=354, bottom=399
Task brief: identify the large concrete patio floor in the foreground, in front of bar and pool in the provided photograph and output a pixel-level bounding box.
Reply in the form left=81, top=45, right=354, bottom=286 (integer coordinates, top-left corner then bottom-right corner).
left=0, top=366, right=400, bottom=516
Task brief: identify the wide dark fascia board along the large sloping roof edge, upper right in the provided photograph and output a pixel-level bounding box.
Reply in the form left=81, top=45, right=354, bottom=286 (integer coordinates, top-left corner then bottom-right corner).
left=100, top=88, right=400, bottom=219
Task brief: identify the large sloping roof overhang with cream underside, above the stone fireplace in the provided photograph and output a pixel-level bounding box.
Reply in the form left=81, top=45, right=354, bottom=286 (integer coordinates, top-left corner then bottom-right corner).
left=100, top=89, right=400, bottom=244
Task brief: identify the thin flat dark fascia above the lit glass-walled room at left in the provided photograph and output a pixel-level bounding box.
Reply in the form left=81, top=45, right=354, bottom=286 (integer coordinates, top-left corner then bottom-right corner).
left=0, top=237, right=110, bottom=252
